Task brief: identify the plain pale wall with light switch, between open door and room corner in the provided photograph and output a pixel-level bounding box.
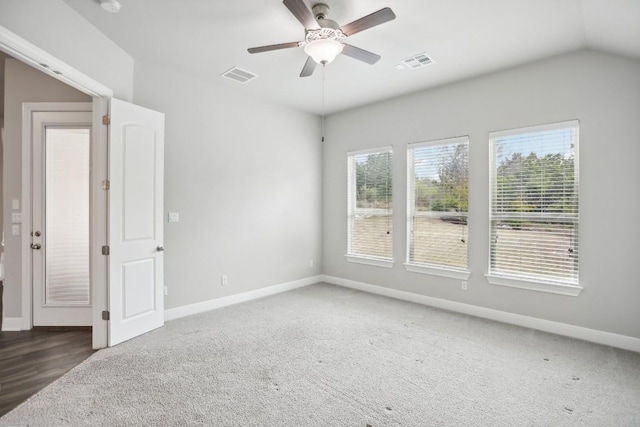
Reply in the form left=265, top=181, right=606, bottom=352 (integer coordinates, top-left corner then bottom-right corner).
left=134, top=62, right=322, bottom=308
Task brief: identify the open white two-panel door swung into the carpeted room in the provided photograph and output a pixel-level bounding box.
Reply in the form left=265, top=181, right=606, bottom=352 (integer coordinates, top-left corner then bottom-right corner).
left=108, top=99, right=164, bottom=346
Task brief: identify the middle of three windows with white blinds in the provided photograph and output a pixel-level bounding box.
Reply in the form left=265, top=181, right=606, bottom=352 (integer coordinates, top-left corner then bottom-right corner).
left=405, top=136, right=469, bottom=280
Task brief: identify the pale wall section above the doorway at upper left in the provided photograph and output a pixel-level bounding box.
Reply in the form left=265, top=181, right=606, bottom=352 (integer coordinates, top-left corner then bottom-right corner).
left=0, top=0, right=134, bottom=101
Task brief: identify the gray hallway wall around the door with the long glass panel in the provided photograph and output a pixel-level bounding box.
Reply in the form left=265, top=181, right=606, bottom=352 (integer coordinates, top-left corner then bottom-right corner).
left=2, top=59, right=91, bottom=317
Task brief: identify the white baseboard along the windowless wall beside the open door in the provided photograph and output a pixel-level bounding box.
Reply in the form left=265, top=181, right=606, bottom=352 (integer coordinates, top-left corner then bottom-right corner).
left=164, top=276, right=322, bottom=320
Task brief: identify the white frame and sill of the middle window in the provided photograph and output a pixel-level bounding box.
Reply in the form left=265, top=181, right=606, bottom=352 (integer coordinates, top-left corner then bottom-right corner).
left=404, top=135, right=471, bottom=280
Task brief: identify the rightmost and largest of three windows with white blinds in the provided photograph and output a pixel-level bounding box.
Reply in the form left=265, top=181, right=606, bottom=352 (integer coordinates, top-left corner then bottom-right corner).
left=487, top=121, right=581, bottom=296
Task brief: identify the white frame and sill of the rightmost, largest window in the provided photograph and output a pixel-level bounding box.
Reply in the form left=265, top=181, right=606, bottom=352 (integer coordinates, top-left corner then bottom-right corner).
left=485, top=120, right=584, bottom=296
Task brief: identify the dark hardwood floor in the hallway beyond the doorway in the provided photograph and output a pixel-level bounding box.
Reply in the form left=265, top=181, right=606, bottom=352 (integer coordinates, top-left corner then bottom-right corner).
left=0, top=328, right=94, bottom=417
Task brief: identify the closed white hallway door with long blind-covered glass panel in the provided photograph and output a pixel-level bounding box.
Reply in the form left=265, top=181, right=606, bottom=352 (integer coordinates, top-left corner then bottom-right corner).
left=31, top=111, right=92, bottom=326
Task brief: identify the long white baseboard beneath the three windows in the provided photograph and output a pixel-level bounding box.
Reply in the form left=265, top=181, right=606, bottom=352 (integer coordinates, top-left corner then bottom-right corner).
left=321, top=276, right=640, bottom=352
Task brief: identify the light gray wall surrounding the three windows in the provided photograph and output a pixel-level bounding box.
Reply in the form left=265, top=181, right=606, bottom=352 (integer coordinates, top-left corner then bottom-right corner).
left=323, top=51, right=640, bottom=338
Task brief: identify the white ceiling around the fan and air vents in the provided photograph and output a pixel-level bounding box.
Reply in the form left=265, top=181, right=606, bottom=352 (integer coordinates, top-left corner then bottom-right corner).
left=65, top=0, right=640, bottom=114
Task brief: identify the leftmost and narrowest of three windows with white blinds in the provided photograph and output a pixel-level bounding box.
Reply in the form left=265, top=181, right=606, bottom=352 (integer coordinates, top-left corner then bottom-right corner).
left=347, top=147, right=393, bottom=267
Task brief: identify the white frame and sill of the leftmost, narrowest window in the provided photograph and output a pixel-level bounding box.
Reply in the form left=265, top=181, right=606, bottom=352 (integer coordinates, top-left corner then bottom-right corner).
left=345, top=145, right=395, bottom=268
